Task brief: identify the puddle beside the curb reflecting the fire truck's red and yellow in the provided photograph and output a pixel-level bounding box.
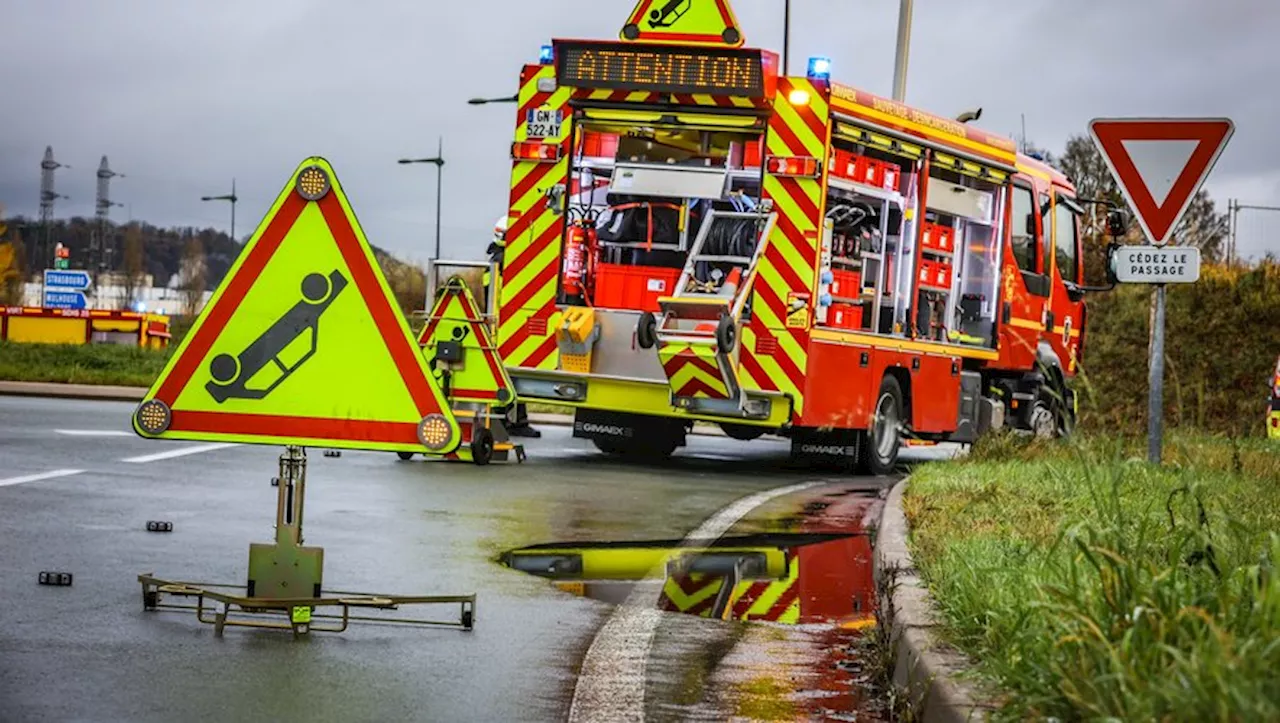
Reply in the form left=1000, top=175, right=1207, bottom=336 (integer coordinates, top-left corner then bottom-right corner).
left=500, top=491, right=887, bottom=720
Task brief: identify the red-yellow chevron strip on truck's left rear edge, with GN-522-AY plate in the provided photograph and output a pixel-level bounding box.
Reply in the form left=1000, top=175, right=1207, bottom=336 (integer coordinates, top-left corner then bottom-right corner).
left=498, top=65, right=572, bottom=370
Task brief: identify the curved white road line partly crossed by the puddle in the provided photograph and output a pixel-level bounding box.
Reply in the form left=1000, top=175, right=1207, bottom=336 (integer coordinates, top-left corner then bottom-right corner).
left=568, top=481, right=826, bottom=722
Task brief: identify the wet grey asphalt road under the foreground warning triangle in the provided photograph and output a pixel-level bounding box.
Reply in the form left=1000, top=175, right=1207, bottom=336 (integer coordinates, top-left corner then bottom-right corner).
left=0, top=397, right=942, bottom=722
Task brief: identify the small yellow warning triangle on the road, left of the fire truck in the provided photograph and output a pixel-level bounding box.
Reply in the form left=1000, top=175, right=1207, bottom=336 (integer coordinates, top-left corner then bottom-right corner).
left=417, top=276, right=515, bottom=406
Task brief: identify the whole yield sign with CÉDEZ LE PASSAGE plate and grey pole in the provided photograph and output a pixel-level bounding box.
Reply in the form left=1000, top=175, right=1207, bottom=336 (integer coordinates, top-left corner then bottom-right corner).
left=1089, top=118, right=1235, bottom=465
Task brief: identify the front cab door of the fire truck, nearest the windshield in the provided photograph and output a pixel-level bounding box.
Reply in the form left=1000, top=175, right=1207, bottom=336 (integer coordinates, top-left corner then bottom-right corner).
left=1044, top=188, right=1084, bottom=375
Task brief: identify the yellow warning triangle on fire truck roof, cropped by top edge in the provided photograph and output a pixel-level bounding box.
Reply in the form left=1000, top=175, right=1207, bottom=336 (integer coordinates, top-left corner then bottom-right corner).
left=621, top=0, right=746, bottom=47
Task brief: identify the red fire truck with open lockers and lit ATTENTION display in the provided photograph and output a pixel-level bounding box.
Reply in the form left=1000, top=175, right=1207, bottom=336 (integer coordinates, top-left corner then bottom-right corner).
left=488, top=3, right=1085, bottom=473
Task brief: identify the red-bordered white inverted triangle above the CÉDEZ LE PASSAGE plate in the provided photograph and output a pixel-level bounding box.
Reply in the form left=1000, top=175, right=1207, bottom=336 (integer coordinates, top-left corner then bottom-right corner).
left=1089, top=118, right=1235, bottom=246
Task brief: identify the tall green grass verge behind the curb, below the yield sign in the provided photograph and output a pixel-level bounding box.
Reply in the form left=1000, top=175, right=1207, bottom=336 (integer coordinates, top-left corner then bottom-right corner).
left=905, top=436, right=1280, bottom=720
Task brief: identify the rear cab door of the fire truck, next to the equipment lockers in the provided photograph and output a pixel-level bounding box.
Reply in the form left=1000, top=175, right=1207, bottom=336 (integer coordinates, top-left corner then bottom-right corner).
left=1000, top=179, right=1051, bottom=370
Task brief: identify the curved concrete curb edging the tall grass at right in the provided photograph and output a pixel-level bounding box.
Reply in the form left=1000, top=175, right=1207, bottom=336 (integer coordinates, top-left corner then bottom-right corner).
left=874, top=480, right=995, bottom=723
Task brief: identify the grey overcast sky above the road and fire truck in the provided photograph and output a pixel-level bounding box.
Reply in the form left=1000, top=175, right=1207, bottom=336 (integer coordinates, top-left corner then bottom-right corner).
left=0, top=0, right=1280, bottom=260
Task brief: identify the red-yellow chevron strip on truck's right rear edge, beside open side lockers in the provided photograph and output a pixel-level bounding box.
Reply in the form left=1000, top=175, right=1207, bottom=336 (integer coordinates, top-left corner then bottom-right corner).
left=739, top=78, right=831, bottom=415
